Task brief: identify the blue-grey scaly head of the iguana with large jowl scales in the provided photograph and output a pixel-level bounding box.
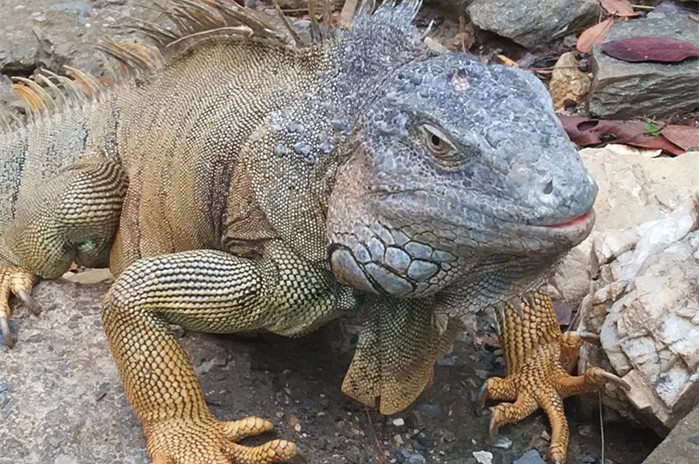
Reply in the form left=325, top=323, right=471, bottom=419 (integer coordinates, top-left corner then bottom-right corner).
left=328, top=54, right=597, bottom=296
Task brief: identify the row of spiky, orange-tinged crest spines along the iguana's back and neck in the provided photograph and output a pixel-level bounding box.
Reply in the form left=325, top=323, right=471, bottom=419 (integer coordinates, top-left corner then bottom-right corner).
left=0, top=0, right=422, bottom=133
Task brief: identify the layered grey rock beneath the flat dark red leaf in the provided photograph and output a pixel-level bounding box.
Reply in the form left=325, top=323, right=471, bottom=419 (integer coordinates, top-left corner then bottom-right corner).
left=589, top=14, right=699, bottom=119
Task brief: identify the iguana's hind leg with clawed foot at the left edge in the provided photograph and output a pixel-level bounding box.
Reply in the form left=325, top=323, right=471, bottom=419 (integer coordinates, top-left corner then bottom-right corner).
left=0, top=156, right=127, bottom=347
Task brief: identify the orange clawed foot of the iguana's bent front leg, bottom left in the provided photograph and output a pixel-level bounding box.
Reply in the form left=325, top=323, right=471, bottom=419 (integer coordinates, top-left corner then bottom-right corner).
left=144, top=417, right=296, bottom=464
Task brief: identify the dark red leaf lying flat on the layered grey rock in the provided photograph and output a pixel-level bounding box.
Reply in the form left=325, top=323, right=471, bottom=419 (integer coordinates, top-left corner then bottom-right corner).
left=601, top=37, right=699, bottom=63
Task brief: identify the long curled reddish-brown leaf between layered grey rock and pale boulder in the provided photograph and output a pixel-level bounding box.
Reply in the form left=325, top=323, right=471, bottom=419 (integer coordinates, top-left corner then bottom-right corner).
left=558, top=114, right=685, bottom=155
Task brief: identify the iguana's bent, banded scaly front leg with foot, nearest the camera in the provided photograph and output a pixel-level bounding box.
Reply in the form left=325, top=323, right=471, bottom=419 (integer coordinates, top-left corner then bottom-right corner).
left=102, top=244, right=349, bottom=464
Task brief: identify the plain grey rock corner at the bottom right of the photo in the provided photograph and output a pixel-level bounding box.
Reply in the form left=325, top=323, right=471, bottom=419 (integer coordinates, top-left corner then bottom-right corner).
left=643, top=406, right=699, bottom=464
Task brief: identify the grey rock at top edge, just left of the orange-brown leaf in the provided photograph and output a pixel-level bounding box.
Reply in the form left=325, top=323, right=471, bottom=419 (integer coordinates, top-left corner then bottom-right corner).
left=466, top=0, right=599, bottom=48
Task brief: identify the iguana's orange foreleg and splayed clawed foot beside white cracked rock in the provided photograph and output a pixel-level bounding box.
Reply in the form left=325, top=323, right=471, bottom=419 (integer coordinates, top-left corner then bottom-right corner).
left=477, top=293, right=629, bottom=464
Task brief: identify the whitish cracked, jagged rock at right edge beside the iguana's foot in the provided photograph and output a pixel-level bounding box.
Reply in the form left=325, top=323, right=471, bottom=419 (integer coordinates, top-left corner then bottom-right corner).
left=584, top=204, right=699, bottom=432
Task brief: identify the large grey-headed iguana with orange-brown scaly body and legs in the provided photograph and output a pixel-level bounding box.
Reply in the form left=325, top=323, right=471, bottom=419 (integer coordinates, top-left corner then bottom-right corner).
left=0, top=0, right=619, bottom=464
